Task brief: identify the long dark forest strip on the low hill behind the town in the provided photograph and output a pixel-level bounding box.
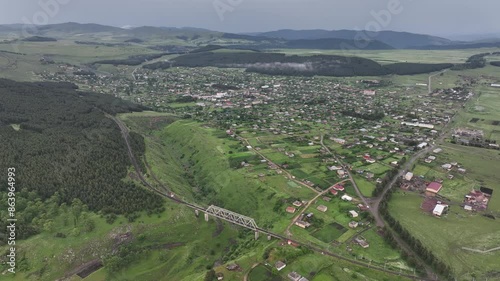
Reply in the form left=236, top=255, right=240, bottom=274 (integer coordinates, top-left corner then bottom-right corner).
left=143, top=52, right=453, bottom=77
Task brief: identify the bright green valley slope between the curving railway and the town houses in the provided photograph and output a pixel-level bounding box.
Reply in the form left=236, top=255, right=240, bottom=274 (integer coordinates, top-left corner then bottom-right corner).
left=154, top=121, right=308, bottom=231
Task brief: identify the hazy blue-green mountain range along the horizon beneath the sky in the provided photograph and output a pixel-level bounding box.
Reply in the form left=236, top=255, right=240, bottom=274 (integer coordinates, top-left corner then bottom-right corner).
left=0, top=22, right=500, bottom=50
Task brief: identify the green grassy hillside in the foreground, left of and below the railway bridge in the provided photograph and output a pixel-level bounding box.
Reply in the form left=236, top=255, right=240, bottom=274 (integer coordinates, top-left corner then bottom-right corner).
left=1, top=195, right=248, bottom=281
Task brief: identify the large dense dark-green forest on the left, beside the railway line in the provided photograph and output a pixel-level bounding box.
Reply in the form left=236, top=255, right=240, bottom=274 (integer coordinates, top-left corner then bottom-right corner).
left=0, top=79, right=163, bottom=240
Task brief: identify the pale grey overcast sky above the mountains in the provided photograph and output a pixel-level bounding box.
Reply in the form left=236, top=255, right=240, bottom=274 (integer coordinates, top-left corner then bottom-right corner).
left=0, top=0, right=500, bottom=35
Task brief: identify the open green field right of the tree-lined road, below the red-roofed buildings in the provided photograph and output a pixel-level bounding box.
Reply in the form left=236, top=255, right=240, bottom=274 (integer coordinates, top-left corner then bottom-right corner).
left=389, top=192, right=500, bottom=280
